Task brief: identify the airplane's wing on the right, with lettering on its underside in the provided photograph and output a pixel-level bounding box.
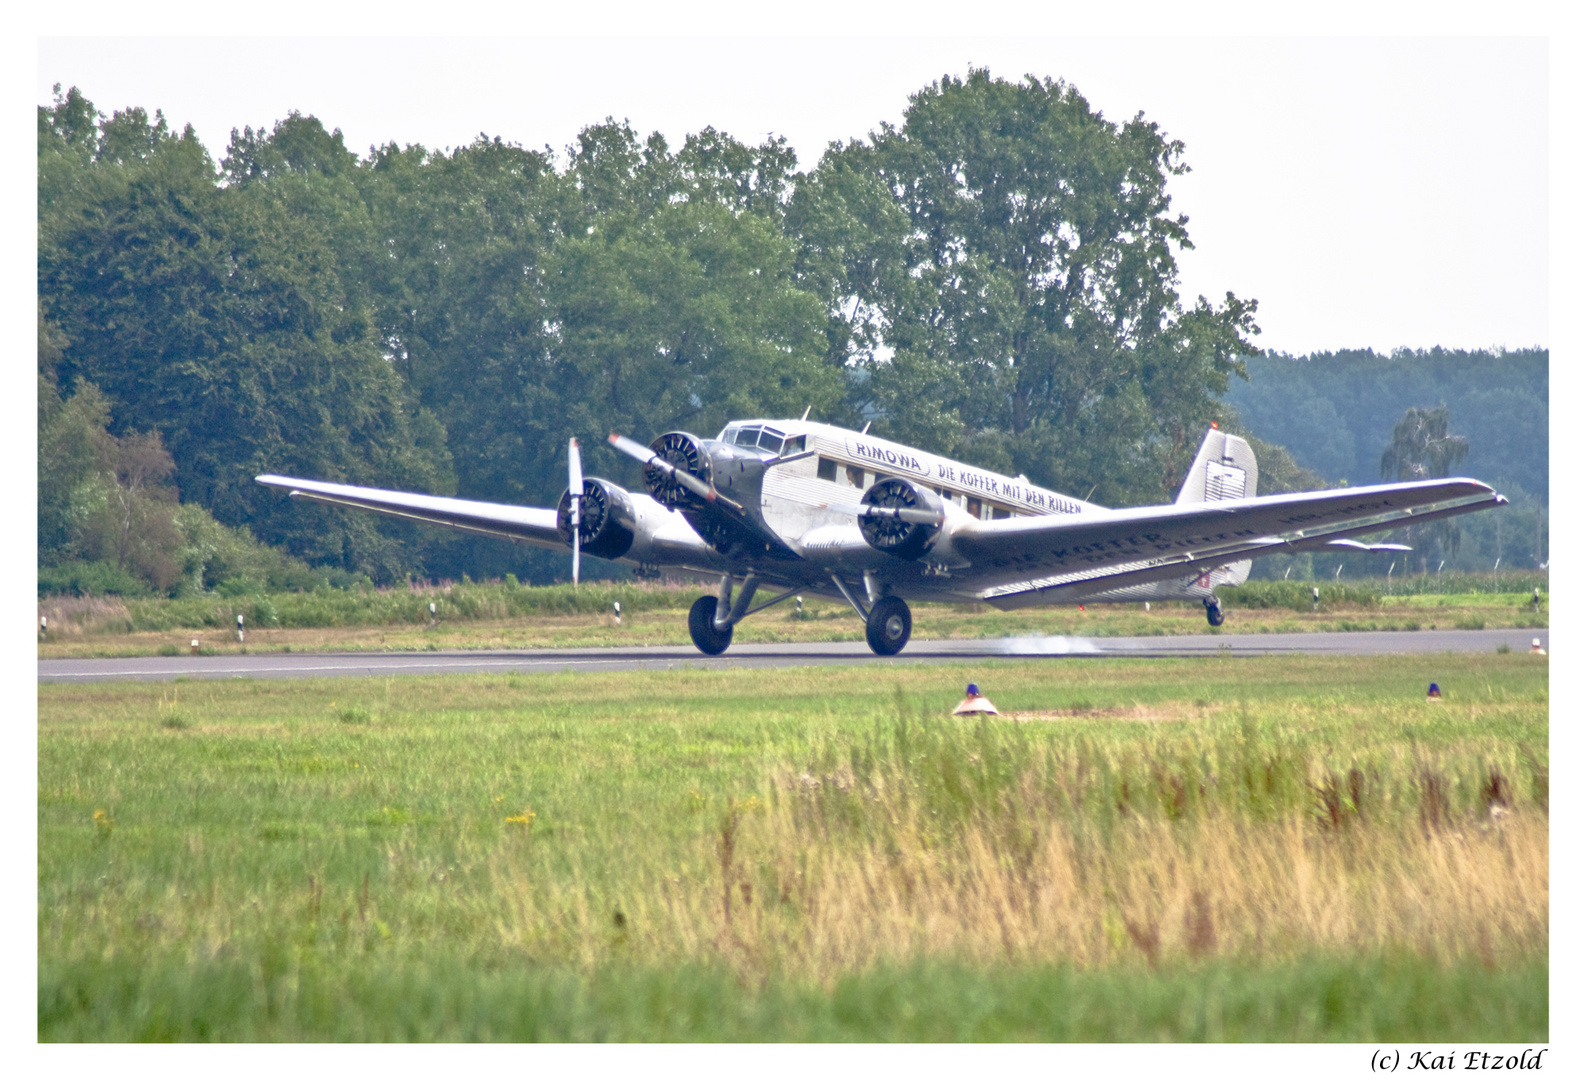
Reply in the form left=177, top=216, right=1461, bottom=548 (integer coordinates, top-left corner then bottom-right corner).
left=934, top=478, right=1505, bottom=607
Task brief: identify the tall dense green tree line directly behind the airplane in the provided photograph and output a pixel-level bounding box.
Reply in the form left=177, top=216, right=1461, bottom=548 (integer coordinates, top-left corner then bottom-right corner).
left=38, top=70, right=1477, bottom=588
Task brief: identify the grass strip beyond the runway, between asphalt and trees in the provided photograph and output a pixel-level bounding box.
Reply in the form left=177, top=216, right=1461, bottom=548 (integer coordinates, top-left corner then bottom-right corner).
left=38, top=573, right=1550, bottom=659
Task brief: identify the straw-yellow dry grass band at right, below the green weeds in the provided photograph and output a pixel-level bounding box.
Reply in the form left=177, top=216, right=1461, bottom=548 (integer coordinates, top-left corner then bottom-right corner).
left=495, top=813, right=1548, bottom=983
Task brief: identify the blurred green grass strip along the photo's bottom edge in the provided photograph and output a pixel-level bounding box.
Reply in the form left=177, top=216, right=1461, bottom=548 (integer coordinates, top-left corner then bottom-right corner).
left=40, top=956, right=1548, bottom=1043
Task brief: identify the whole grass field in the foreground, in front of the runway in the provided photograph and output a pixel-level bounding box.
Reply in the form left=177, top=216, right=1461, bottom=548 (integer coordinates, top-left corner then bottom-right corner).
left=38, top=654, right=1548, bottom=1042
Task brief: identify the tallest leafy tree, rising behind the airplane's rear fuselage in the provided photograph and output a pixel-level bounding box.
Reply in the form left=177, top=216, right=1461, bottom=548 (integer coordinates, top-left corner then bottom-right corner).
left=823, top=70, right=1258, bottom=502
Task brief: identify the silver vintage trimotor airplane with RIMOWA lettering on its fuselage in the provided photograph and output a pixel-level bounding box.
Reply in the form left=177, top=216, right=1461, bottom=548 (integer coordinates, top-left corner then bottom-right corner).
left=257, top=410, right=1505, bottom=656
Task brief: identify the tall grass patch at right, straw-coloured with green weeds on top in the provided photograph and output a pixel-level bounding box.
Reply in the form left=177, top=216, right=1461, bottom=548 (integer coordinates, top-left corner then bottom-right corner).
left=491, top=721, right=1548, bottom=983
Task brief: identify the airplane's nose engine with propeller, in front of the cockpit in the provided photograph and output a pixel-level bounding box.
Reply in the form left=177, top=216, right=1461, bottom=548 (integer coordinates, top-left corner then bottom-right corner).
left=610, top=432, right=799, bottom=559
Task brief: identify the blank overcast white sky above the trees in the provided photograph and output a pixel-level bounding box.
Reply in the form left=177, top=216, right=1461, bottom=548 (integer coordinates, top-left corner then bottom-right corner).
left=37, top=32, right=1548, bottom=353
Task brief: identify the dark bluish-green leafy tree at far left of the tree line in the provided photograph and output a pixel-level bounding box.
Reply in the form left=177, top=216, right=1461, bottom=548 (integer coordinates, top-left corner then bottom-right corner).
left=40, top=95, right=451, bottom=578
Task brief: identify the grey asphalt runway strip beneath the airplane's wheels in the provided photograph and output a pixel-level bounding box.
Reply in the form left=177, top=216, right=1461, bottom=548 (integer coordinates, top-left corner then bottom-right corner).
left=38, top=631, right=1550, bottom=685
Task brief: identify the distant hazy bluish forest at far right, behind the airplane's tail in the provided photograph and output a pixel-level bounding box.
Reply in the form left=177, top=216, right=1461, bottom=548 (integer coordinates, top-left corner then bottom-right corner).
left=1224, top=348, right=1550, bottom=575
